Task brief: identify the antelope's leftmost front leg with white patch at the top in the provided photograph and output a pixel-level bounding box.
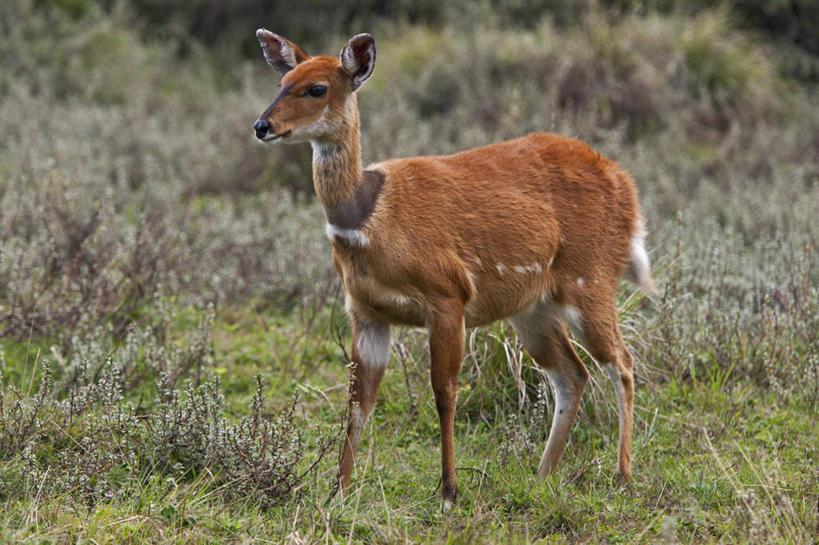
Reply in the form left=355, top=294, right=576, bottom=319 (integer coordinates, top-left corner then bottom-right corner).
left=338, top=316, right=390, bottom=494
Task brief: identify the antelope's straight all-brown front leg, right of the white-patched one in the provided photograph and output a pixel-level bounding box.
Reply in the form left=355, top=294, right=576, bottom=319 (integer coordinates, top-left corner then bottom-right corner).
left=429, top=303, right=464, bottom=511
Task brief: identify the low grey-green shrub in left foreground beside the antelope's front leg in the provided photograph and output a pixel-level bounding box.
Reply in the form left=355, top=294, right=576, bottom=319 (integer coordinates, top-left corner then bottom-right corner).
left=0, top=315, right=336, bottom=507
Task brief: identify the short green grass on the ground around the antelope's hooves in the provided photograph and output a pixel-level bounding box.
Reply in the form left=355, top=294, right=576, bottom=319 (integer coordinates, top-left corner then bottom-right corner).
left=0, top=309, right=819, bottom=543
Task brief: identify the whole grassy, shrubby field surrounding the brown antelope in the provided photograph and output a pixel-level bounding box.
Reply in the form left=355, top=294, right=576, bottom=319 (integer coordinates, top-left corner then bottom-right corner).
left=0, top=0, right=819, bottom=544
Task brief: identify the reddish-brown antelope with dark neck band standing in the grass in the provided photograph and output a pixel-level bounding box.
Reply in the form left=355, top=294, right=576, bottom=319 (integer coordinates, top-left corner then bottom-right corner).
left=253, top=29, right=652, bottom=509
